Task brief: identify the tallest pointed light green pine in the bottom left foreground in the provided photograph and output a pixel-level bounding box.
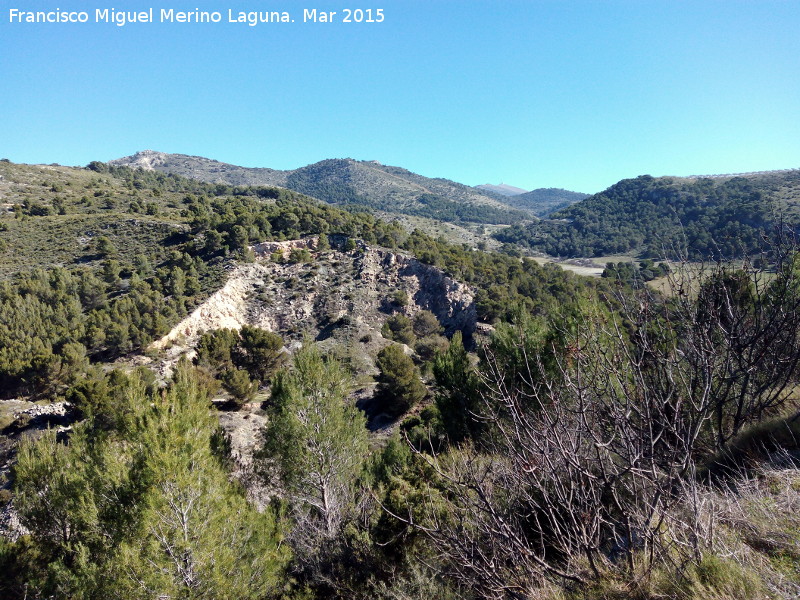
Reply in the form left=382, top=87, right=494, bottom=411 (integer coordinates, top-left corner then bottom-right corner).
left=111, top=365, right=288, bottom=598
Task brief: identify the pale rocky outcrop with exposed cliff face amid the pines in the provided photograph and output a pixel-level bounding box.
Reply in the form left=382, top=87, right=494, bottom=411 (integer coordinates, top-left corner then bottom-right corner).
left=153, top=238, right=477, bottom=357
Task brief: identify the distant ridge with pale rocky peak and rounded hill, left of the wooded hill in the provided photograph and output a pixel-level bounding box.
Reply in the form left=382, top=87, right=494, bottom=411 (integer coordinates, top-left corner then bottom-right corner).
left=109, top=150, right=532, bottom=224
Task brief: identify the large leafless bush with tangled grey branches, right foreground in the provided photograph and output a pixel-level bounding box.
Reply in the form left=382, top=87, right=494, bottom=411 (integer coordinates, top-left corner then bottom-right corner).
left=398, top=241, right=800, bottom=598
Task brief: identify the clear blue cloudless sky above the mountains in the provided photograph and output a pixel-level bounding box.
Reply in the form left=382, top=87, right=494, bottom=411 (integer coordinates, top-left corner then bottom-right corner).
left=0, top=0, right=800, bottom=192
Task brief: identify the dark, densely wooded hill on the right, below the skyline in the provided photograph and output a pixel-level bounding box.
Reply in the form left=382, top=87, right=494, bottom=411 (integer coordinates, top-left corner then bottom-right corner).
left=496, top=169, right=800, bottom=258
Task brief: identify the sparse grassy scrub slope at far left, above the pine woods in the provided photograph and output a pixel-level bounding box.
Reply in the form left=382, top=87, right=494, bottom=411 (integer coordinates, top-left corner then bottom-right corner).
left=0, top=162, right=202, bottom=279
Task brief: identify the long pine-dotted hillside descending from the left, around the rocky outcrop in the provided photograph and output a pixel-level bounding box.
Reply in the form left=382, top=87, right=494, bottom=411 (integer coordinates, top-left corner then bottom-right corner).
left=0, top=154, right=583, bottom=418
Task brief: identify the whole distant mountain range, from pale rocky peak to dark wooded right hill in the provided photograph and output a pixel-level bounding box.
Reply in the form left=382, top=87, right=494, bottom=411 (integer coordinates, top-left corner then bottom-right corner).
left=109, top=150, right=800, bottom=259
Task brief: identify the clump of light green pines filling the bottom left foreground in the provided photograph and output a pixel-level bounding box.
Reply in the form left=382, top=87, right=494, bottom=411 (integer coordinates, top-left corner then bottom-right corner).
left=15, top=364, right=289, bottom=599
